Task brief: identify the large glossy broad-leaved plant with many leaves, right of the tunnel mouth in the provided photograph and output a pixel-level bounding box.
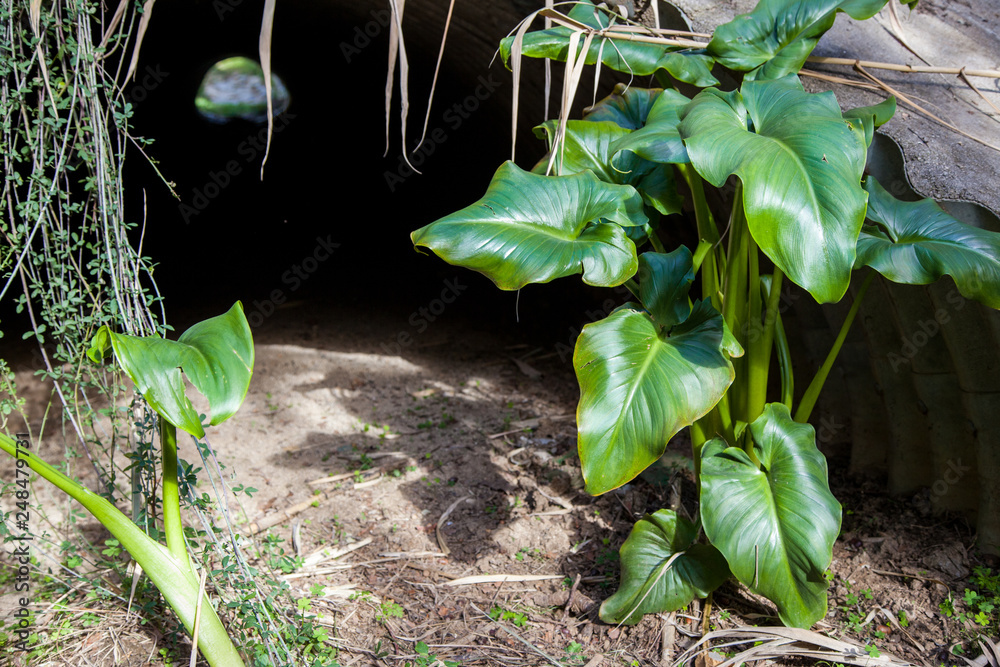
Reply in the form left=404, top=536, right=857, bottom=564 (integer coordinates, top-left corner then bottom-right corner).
left=411, top=0, right=1000, bottom=628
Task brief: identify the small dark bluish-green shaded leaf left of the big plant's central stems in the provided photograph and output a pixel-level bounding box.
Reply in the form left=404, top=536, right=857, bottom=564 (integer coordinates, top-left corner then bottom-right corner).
left=638, top=246, right=694, bottom=328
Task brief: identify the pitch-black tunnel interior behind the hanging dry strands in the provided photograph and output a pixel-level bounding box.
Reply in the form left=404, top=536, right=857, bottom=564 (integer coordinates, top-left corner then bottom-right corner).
left=115, top=0, right=621, bottom=342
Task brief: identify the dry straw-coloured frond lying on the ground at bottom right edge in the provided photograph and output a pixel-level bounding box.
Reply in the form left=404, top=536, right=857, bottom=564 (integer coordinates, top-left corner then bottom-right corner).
left=673, top=627, right=912, bottom=667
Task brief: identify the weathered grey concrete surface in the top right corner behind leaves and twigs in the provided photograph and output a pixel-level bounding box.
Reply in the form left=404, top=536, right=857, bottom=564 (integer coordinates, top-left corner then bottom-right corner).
left=674, top=0, right=1000, bottom=213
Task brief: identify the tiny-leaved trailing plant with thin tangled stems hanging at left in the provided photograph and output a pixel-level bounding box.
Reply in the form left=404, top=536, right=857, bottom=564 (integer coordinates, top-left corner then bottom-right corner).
left=0, top=0, right=329, bottom=665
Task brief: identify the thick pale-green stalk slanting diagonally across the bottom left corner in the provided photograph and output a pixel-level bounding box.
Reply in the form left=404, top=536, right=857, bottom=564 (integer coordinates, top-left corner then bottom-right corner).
left=0, top=433, right=245, bottom=667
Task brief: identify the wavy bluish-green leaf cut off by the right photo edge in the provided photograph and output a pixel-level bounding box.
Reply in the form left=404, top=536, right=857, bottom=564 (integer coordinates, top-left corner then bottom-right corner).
left=858, top=176, right=1000, bottom=308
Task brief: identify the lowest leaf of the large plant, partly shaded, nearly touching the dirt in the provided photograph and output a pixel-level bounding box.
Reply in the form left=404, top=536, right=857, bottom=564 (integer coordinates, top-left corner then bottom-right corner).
left=600, top=510, right=729, bottom=625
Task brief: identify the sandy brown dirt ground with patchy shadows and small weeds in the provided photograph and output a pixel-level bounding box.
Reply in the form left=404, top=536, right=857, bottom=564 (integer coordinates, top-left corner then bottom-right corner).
left=0, top=304, right=997, bottom=667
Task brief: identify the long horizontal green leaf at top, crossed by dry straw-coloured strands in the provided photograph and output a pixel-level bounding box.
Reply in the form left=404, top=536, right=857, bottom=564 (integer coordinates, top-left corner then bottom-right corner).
left=500, top=0, right=719, bottom=87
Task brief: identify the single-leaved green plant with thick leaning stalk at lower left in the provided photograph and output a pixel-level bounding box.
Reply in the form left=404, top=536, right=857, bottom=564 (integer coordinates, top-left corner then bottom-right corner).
left=0, top=302, right=254, bottom=667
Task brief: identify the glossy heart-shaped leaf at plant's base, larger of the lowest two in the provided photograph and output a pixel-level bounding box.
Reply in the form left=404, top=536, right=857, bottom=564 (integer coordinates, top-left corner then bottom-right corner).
left=701, top=403, right=841, bottom=628
